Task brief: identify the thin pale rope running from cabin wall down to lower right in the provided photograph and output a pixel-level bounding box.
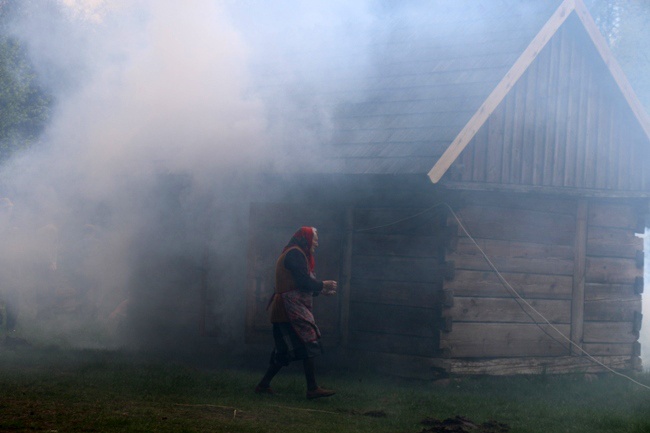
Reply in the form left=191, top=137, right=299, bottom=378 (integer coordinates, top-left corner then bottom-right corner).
left=354, top=202, right=650, bottom=390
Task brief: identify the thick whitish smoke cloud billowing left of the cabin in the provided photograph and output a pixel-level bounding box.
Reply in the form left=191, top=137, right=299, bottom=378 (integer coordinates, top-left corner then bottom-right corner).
left=2, top=1, right=267, bottom=345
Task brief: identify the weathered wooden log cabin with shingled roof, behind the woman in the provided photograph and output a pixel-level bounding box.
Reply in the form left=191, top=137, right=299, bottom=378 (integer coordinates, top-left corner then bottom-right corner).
left=240, top=0, right=650, bottom=377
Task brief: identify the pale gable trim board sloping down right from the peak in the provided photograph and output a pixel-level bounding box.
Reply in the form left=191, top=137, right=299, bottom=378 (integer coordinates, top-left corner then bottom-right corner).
left=574, top=0, right=650, bottom=139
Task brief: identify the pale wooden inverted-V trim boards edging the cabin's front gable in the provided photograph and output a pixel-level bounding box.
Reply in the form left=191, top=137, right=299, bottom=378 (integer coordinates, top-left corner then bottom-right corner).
left=428, top=0, right=650, bottom=183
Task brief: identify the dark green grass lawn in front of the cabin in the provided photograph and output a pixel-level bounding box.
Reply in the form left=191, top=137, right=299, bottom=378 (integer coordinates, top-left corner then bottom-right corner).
left=0, top=347, right=650, bottom=433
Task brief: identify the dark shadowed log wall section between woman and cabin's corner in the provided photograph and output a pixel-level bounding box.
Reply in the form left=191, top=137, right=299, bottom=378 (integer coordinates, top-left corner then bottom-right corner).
left=347, top=207, right=446, bottom=357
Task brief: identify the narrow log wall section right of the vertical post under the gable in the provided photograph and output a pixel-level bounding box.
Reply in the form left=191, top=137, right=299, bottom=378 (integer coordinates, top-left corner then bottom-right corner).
left=583, top=201, right=644, bottom=358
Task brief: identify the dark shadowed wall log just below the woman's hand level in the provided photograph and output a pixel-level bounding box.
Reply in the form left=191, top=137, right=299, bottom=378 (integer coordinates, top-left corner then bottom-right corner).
left=349, top=302, right=440, bottom=338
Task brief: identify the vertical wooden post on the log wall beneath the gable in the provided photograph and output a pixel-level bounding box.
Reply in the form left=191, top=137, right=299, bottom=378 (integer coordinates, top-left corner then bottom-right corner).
left=571, top=199, right=587, bottom=355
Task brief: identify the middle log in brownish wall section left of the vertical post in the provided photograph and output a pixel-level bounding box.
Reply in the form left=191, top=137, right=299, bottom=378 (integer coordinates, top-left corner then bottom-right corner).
left=444, top=269, right=573, bottom=299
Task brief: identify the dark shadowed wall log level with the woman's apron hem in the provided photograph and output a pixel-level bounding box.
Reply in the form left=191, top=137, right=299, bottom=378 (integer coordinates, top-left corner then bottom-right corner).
left=348, top=330, right=440, bottom=357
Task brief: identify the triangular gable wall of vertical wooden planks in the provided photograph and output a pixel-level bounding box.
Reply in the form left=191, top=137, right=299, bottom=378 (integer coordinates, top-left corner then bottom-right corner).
left=454, top=17, right=650, bottom=191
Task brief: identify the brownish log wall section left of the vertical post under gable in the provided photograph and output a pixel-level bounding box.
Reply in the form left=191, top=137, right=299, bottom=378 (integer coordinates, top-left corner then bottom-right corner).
left=441, top=194, right=577, bottom=358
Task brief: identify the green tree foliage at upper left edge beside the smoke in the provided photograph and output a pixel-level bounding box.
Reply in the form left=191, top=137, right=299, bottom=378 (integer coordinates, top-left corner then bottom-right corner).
left=0, top=0, right=52, bottom=161
